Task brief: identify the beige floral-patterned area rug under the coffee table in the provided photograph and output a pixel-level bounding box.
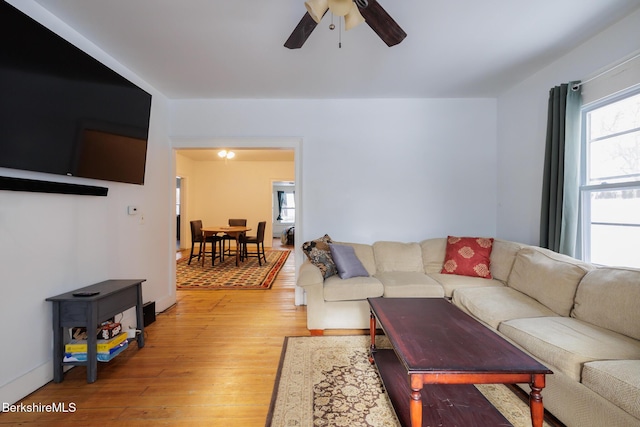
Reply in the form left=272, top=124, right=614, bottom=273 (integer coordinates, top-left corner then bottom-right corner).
left=266, top=335, right=550, bottom=427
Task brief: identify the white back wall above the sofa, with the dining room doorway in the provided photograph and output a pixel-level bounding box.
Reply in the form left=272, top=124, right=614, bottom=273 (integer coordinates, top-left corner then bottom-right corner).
left=170, top=99, right=496, bottom=243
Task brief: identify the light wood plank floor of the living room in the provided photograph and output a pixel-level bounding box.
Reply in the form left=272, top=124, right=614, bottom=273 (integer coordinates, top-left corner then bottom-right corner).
left=0, top=241, right=366, bottom=427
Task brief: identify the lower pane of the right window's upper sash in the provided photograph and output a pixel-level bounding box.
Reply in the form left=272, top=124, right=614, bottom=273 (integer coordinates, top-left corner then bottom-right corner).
left=588, top=131, right=640, bottom=185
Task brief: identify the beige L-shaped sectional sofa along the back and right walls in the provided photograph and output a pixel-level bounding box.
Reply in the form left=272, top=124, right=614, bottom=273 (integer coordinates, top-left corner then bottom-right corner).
left=297, top=238, right=640, bottom=427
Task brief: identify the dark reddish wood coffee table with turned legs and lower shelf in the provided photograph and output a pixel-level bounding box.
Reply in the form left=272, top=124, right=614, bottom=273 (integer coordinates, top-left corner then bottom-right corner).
left=368, top=298, right=553, bottom=427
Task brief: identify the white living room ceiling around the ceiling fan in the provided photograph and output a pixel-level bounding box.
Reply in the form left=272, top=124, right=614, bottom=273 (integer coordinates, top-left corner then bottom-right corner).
left=31, top=0, right=640, bottom=99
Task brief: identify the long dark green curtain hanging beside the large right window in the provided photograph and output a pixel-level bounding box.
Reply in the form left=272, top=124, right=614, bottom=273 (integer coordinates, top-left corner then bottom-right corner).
left=540, top=82, right=581, bottom=256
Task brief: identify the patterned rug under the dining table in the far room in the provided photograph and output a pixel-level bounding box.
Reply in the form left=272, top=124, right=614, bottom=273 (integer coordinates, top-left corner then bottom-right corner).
left=176, top=250, right=290, bottom=290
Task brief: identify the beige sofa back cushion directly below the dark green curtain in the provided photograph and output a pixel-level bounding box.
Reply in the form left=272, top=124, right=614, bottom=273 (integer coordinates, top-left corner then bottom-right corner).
left=507, top=246, right=594, bottom=316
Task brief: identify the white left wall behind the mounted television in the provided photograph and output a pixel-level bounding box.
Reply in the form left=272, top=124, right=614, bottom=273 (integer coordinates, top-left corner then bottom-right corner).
left=0, top=1, right=175, bottom=403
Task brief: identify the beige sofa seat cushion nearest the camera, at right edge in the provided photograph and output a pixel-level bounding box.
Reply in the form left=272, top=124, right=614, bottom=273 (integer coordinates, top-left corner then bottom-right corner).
left=582, top=360, right=640, bottom=419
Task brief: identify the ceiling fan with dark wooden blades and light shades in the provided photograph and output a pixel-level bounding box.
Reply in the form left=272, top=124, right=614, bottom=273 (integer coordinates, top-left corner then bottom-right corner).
left=284, top=0, right=407, bottom=49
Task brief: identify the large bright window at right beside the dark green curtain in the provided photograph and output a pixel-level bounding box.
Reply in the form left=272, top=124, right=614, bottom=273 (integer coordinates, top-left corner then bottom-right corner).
left=580, top=87, right=640, bottom=267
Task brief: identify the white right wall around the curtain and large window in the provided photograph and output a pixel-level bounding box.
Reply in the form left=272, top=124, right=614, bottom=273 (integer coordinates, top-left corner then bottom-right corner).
left=497, top=11, right=640, bottom=244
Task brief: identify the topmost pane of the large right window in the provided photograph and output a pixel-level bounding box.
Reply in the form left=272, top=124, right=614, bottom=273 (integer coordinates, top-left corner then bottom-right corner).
left=587, top=94, right=640, bottom=139
